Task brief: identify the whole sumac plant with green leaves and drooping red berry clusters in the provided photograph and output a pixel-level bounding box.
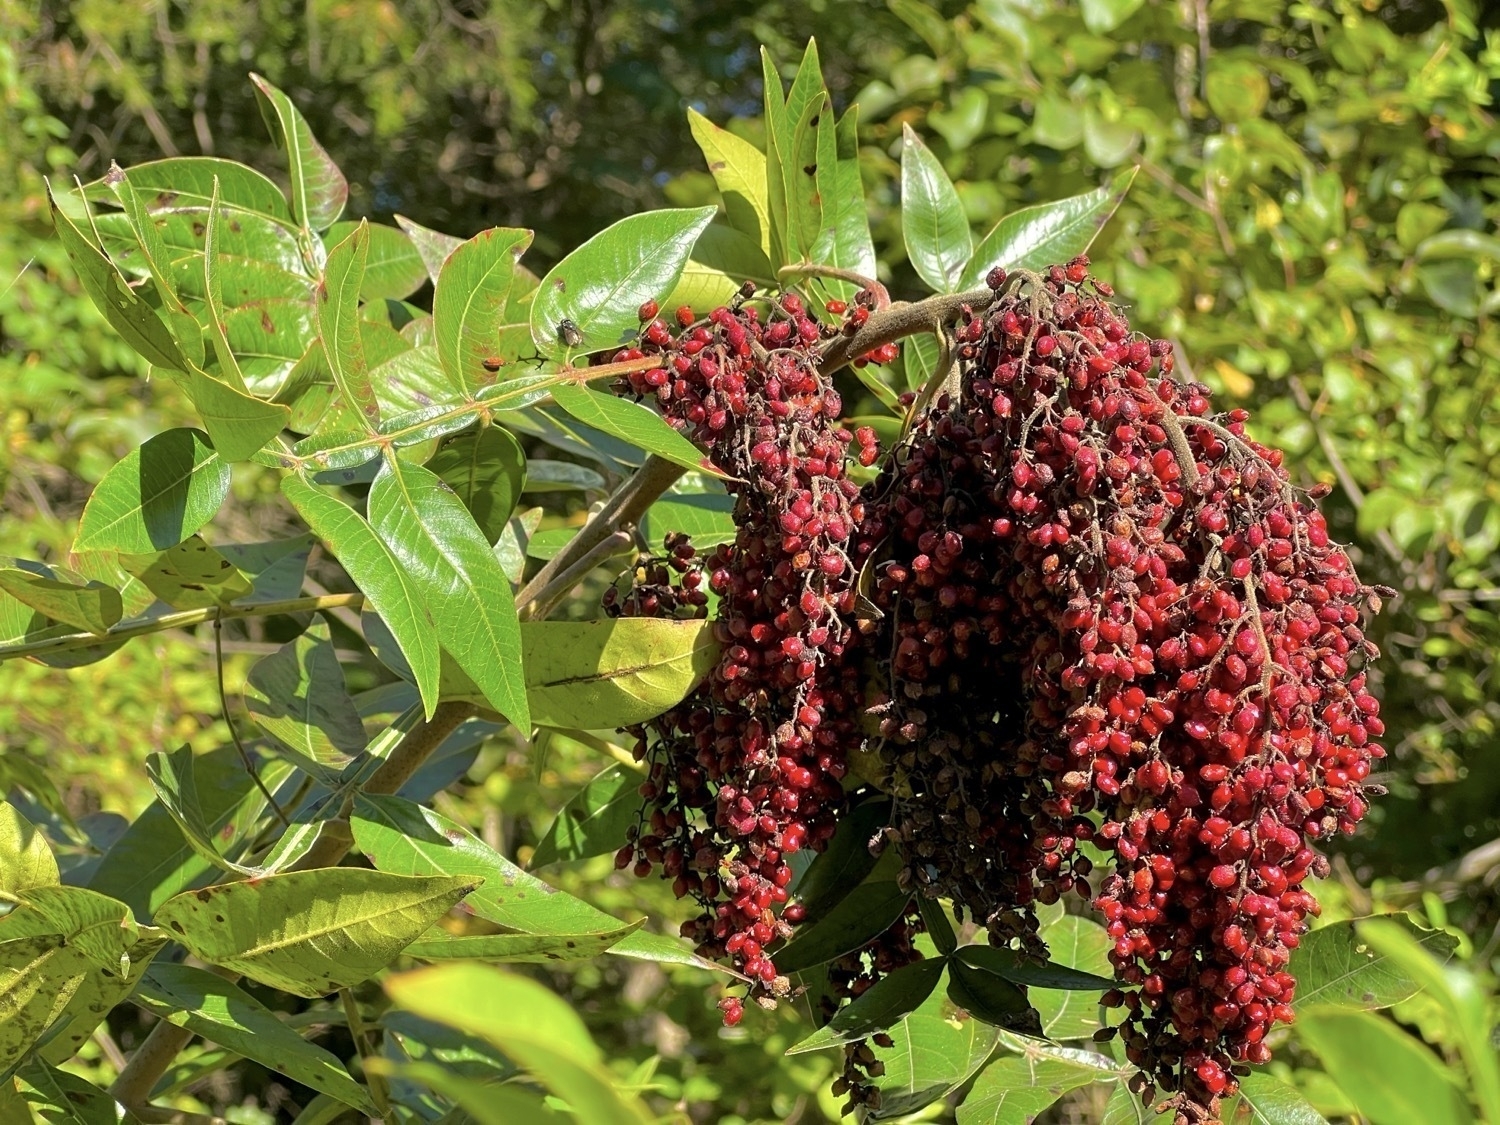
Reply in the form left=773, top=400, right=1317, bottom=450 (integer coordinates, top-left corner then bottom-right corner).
left=0, top=41, right=1446, bottom=1125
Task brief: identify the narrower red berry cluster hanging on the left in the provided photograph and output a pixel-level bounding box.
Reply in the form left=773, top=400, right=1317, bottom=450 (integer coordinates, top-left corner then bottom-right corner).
left=615, top=288, right=873, bottom=1002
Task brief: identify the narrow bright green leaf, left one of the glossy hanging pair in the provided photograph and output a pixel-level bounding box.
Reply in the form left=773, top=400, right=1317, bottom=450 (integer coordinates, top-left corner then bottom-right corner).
left=281, top=474, right=443, bottom=719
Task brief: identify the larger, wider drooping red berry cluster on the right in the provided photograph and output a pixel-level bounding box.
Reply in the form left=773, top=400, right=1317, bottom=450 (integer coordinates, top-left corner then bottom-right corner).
left=861, top=258, right=1383, bottom=1122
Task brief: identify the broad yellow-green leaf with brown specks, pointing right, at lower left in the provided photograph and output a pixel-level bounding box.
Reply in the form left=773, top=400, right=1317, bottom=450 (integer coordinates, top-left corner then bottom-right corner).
left=155, top=867, right=474, bottom=998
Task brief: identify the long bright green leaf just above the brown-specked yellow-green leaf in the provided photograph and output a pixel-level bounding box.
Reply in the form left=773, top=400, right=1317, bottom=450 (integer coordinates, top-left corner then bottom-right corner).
left=351, top=795, right=717, bottom=969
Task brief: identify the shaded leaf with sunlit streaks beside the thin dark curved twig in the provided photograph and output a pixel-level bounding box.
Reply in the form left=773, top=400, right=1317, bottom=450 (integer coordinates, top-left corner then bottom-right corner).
left=245, top=621, right=366, bottom=770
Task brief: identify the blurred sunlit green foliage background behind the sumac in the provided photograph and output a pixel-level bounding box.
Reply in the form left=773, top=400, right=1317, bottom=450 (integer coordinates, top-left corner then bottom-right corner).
left=0, top=0, right=1500, bottom=1125
